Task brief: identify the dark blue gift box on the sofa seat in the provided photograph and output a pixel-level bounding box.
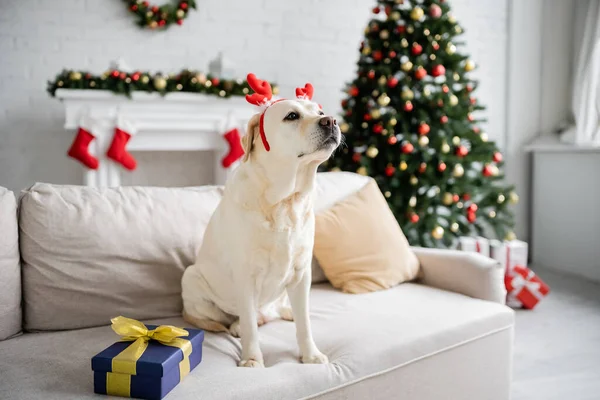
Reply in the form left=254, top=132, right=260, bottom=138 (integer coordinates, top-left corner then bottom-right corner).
left=92, top=325, right=204, bottom=400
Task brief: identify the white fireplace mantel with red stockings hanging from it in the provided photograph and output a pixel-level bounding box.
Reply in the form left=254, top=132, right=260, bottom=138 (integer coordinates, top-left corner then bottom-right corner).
left=56, top=89, right=255, bottom=187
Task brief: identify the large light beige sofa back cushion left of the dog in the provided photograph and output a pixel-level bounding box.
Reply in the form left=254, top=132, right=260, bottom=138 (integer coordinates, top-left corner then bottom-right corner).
left=19, top=184, right=222, bottom=330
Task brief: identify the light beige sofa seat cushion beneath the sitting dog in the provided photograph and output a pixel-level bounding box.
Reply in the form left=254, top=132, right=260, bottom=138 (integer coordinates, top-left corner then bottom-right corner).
left=0, top=283, right=513, bottom=400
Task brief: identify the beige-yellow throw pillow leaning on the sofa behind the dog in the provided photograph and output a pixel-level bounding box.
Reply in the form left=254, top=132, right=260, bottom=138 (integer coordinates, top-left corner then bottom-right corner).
left=314, top=180, right=419, bottom=293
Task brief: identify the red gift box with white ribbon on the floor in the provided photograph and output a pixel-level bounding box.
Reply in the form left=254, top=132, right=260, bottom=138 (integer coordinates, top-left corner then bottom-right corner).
left=504, top=265, right=550, bottom=310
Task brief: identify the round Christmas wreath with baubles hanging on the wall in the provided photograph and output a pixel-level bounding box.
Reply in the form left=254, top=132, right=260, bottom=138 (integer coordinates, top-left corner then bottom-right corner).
left=123, top=0, right=196, bottom=29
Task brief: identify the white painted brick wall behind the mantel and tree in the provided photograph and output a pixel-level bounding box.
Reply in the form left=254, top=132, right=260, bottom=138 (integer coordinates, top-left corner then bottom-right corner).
left=0, top=0, right=507, bottom=194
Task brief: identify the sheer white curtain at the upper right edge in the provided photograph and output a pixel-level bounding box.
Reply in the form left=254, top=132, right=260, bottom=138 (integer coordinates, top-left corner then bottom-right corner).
left=561, top=0, right=600, bottom=147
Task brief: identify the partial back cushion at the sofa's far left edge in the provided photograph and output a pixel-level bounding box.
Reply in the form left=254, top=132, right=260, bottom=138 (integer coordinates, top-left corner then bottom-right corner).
left=0, top=187, right=21, bottom=340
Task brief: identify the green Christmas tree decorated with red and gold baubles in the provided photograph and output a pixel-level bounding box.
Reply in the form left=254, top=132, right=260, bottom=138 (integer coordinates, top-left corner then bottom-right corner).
left=324, top=0, right=518, bottom=247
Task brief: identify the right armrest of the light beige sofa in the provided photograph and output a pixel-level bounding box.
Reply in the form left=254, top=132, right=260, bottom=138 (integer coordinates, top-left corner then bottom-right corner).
left=412, top=247, right=506, bottom=304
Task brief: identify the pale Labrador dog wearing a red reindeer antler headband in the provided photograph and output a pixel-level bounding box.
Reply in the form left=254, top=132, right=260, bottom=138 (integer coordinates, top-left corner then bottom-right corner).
left=182, top=75, right=341, bottom=367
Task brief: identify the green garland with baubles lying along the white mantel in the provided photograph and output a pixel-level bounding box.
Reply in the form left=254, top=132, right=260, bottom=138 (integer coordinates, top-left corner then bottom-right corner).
left=47, top=69, right=279, bottom=97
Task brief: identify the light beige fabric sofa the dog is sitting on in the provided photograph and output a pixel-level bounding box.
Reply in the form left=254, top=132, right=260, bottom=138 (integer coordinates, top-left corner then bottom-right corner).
left=0, top=173, right=514, bottom=400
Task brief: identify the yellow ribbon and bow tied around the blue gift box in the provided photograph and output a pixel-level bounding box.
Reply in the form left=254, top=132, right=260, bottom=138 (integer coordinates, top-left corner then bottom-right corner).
left=106, top=317, right=192, bottom=397
